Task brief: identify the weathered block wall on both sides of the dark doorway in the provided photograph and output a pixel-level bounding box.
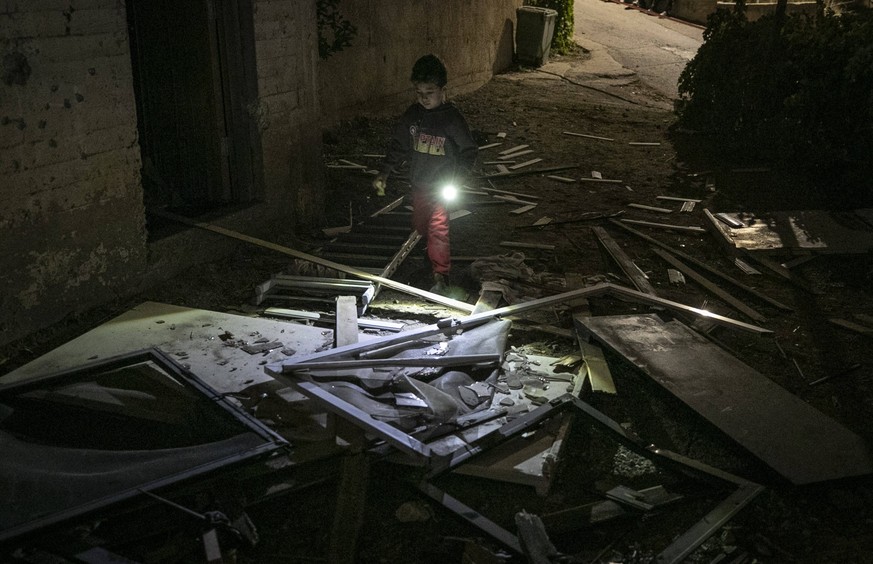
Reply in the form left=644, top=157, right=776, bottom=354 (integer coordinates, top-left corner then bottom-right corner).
left=0, top=0, right=323, bottom=344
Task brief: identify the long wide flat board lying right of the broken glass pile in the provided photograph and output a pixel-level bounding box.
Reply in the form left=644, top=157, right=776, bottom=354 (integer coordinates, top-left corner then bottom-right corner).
left=577, top=315, right=873, bottom=485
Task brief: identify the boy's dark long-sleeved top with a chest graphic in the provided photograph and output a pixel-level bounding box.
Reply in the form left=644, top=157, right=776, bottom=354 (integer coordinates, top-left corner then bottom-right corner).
left=382, top=103, right=479, bottom=188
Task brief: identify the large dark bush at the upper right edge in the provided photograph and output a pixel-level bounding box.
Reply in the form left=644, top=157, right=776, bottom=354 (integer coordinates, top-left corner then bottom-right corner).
left=676, top=7, right=873, bottom=205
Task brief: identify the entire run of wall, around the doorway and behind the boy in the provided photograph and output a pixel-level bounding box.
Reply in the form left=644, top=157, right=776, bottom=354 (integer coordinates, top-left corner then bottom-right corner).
left=0, top=0, right=521, bottom=345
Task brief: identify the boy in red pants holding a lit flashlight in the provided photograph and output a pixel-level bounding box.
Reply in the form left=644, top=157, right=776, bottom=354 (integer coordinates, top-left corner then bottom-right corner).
left=373, top=55, right=479, bottom=294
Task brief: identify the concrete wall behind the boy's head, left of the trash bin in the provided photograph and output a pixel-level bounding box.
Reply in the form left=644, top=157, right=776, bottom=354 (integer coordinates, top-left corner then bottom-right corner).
left=318, top=0, right=523, bottom=125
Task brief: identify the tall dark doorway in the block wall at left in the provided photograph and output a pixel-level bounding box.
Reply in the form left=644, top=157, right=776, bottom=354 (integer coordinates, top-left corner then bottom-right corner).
left=127, top=0, right=262, bottom=215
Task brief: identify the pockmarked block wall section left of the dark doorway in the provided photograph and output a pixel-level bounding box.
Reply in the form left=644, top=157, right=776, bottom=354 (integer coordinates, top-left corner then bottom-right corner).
left=0, top=0, right=146, bottom=343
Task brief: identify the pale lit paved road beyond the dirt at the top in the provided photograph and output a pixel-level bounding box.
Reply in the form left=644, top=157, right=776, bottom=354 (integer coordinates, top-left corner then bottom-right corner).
left=574, top=0, right=703, bottom=99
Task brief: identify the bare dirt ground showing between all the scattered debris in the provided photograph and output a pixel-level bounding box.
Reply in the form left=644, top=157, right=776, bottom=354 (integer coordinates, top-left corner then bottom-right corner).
left=0, top=52, right=873, bottom=563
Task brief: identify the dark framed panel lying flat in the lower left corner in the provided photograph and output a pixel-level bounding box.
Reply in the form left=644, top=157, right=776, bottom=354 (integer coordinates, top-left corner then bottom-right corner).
left=0, top=349, right=286, bottom=541
